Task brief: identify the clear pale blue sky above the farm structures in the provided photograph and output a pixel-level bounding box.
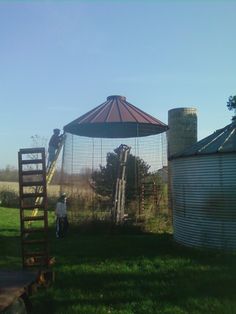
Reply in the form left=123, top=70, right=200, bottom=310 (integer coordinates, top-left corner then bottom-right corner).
left=0, top=0, right=236, bottom=168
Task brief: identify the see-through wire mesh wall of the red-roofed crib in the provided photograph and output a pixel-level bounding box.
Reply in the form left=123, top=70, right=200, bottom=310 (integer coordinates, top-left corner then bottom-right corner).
left=61, top=133, right=168, bottom=223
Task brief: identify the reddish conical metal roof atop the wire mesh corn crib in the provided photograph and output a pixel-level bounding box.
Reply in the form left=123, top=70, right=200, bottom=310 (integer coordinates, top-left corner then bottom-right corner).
left=64, top=95, right=168, bottom=138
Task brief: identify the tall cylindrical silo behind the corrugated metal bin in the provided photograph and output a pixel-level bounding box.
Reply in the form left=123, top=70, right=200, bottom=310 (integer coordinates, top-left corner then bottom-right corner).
left=167, top=108, right=197, bottom=156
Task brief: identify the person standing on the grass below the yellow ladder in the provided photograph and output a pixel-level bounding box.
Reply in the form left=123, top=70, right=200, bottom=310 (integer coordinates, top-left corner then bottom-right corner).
left=55, top=193, right=69, bottom=238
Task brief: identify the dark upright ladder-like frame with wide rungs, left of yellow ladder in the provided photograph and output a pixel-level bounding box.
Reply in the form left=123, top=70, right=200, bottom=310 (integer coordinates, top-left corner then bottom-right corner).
left=18, top=148, right=49, bottom=269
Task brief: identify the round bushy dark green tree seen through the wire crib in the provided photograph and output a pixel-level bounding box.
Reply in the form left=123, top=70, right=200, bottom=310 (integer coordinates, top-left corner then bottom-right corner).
left=91, top=148, right=150, bottom=201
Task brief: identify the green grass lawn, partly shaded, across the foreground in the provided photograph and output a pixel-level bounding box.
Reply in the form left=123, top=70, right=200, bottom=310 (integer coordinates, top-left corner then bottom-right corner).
left=0, top=208, right=236, bottom=314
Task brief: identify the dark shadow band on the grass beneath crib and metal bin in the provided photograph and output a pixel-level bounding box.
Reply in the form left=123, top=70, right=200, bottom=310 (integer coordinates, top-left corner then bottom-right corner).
left=50, top=224, right=236, bottom=266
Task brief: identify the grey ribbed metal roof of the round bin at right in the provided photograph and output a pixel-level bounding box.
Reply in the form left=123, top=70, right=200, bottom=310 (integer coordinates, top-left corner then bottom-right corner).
left=170, top=120, right=236, bottom=159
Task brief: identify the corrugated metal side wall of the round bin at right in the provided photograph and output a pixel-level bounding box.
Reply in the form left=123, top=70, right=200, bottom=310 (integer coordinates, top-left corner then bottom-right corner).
left=171, top=153, right=236, bottom=250
